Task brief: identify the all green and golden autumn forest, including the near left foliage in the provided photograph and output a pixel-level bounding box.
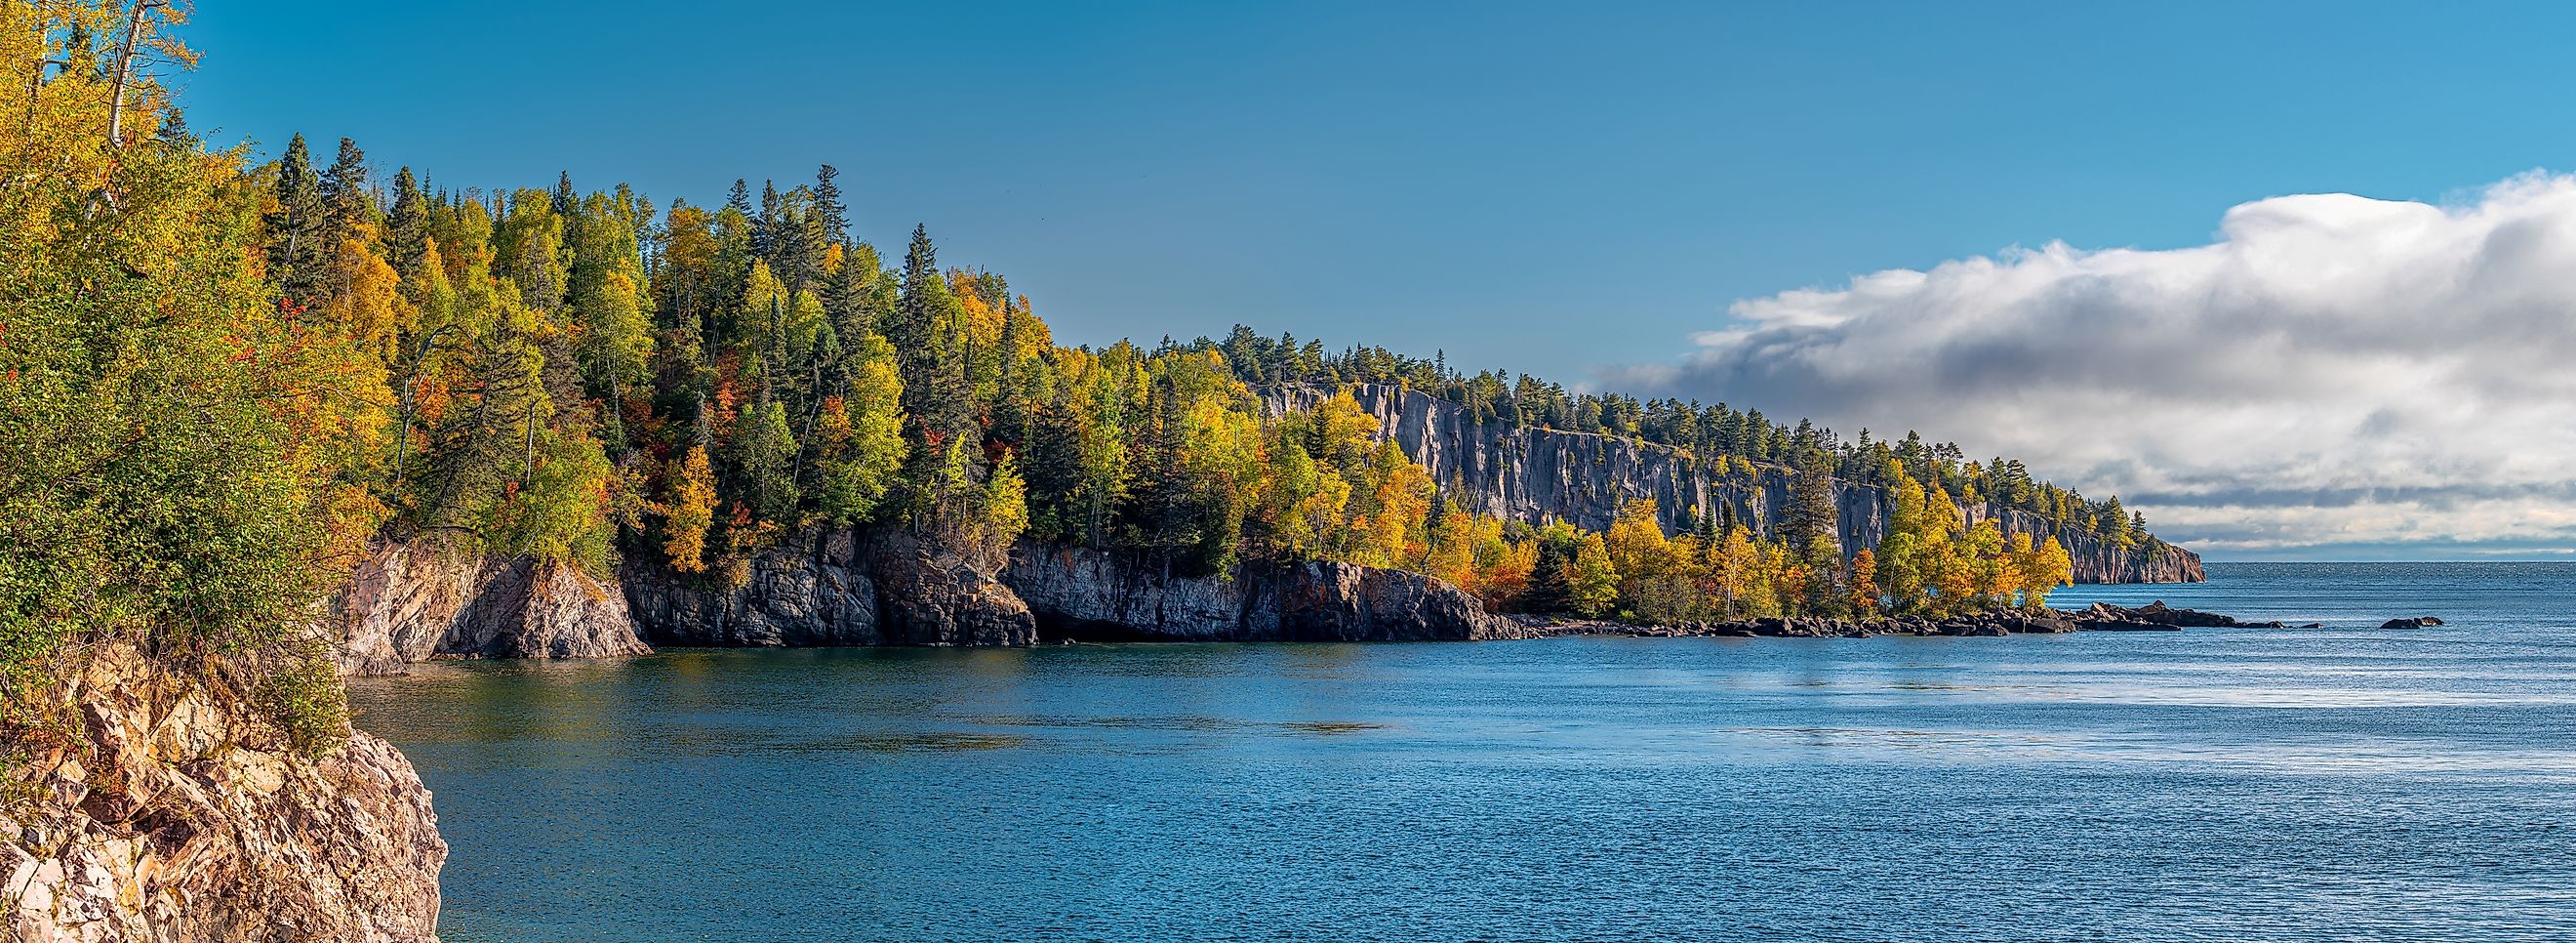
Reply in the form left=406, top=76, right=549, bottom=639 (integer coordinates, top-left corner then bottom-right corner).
left=0, top=3, right=2153, bottom=731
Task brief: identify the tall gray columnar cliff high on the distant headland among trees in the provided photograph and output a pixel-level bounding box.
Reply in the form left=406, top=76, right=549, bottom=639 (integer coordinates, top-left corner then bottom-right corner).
left=1260, top=384, right=2205, bottom=582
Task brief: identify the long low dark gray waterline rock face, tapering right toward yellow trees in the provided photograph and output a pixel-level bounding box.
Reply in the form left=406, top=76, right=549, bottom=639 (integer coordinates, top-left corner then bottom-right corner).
left=1002, top=544, right=1507, bottom=641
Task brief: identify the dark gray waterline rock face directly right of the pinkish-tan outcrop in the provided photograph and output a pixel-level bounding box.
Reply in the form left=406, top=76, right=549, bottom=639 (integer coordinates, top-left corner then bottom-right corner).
left=621, top=528, right=1038, bottom=646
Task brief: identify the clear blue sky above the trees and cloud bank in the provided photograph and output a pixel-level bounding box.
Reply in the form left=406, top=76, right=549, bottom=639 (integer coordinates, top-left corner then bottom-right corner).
left=182, top=3, right=2576, bottom=552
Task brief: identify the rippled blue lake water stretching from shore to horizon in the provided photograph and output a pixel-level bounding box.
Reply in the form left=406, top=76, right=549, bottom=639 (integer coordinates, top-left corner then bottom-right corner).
left=353, top=564, right=2576, bottom=940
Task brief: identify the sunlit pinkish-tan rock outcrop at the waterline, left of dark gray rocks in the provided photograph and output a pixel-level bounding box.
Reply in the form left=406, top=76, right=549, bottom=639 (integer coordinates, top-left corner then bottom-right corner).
left=330, top=541, right=652, bottom=676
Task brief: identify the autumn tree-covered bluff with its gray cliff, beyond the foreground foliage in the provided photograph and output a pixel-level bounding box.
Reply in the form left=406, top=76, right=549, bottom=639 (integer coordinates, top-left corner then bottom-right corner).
left=171, top=125, right=2197, bottom=641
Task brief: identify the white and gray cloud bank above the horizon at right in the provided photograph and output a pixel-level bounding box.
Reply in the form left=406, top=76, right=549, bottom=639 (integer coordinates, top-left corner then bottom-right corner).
left=1618, top=175, right=2576, bottom=556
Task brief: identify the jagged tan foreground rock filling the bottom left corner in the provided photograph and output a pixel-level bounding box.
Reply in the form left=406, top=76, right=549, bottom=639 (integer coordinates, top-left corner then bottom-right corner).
left=0, top=644, right=448, bottom=943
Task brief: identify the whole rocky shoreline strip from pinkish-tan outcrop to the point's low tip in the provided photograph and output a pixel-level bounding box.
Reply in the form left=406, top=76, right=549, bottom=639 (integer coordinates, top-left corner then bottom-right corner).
left=335, top=528, right=2442, bottom=676
